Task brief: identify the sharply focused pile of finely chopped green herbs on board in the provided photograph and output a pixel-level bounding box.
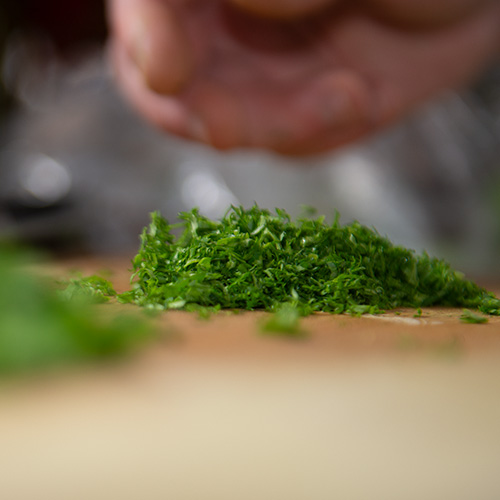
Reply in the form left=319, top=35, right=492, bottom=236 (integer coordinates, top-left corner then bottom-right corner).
left=120, top=206, right=500, bottom=315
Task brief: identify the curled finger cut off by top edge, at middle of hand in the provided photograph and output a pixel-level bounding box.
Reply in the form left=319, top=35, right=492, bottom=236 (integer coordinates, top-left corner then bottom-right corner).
left=228, top=0, right=338, bottom=19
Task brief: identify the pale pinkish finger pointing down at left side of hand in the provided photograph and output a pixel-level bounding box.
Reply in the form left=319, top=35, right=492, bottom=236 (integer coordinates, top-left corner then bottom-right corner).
left=109, top=0, right=194, bottom=94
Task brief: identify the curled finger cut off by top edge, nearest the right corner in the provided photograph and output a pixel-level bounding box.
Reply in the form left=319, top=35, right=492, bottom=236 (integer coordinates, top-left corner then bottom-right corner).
left=363, top=0, right=496, bottom=27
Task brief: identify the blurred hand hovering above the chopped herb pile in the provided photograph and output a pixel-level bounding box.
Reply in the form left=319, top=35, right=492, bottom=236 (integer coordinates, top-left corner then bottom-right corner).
left=109, top=0, right=500, bottom=155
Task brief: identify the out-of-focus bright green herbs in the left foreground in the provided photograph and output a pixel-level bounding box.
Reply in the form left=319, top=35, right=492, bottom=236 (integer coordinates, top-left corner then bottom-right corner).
left=0, top=248, right=152, bottom=376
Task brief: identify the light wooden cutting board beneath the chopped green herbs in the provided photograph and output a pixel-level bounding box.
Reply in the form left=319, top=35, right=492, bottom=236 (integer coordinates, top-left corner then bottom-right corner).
left=0, top=259, right=500, bottom=500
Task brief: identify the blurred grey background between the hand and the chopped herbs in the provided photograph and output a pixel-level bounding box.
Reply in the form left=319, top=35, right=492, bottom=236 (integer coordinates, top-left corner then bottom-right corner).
left=0, top=0, right=500, bottom=277
